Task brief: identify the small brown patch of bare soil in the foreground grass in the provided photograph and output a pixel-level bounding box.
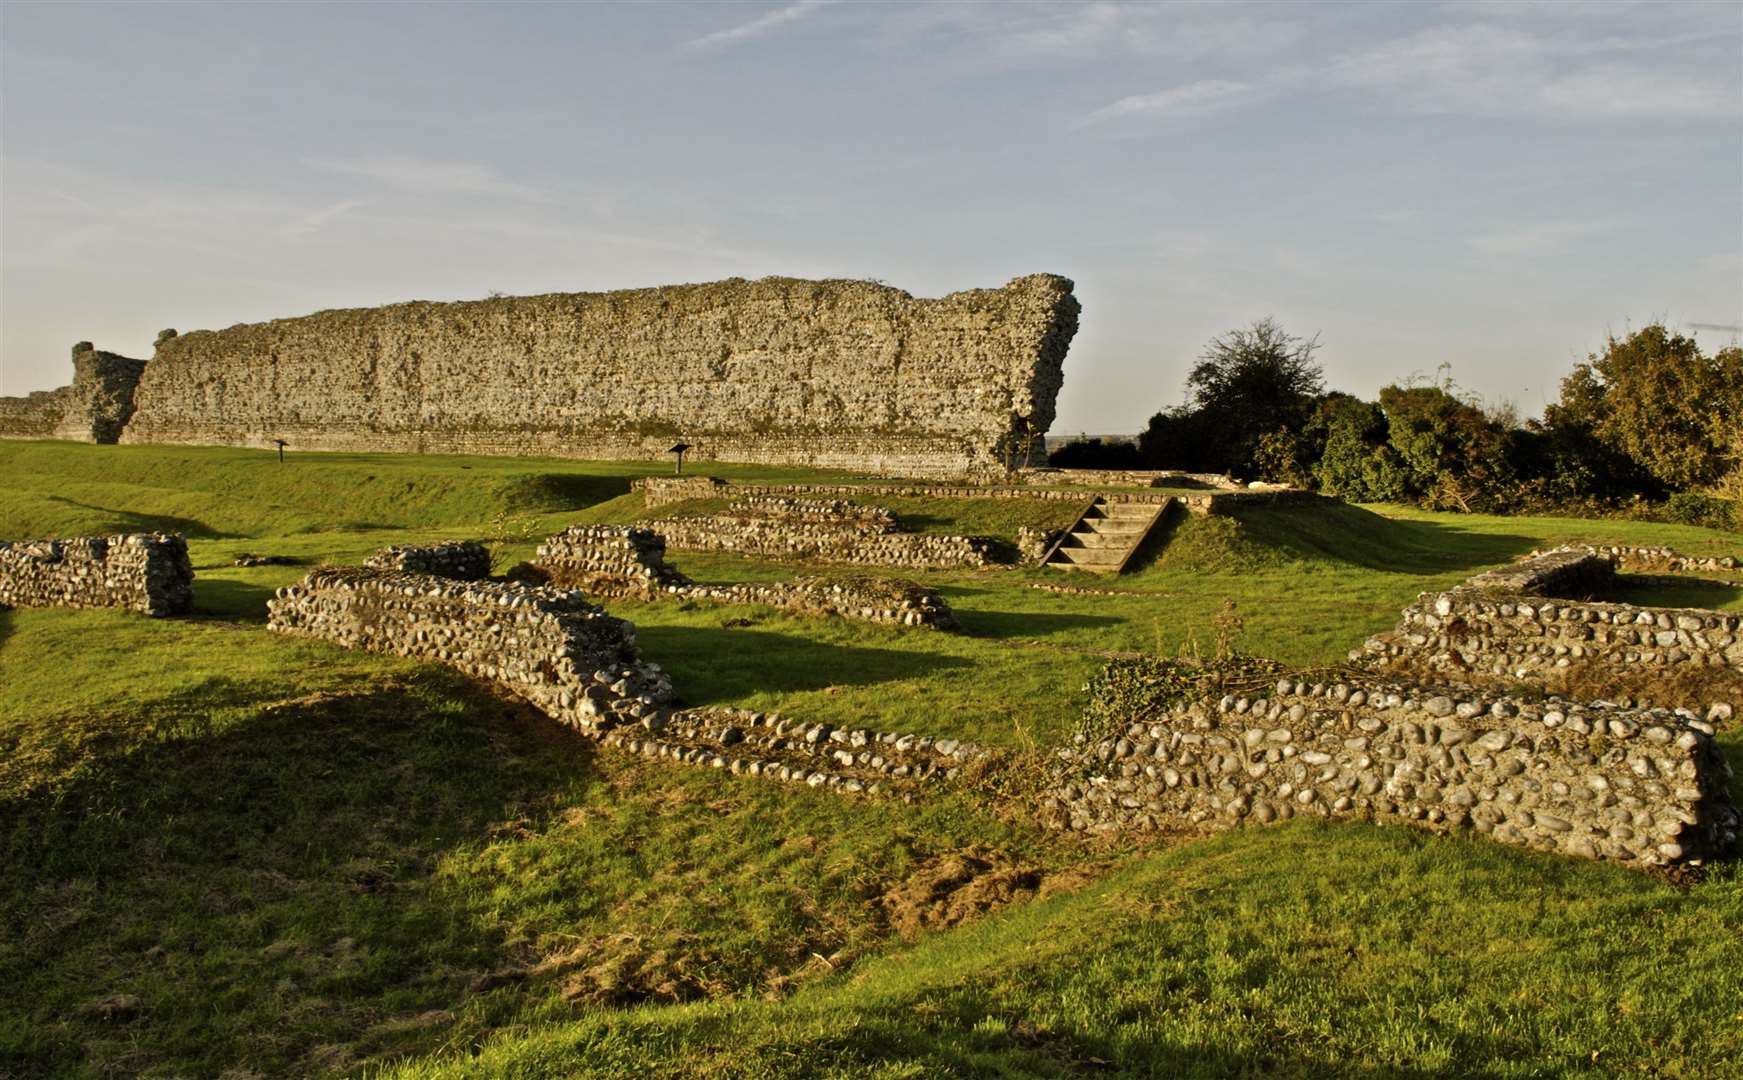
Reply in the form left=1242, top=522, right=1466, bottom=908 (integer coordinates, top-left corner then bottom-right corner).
left=877, top=845, right=1096, bottom=937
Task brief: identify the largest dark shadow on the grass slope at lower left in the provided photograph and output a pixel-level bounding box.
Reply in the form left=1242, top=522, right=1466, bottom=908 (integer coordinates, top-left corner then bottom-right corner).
left=0, top=676, right=593, bottom=1075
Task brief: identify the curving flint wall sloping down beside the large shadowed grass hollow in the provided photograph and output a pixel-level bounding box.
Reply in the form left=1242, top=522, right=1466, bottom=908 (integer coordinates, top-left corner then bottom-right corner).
left=267, top=566, right=673, bottom=735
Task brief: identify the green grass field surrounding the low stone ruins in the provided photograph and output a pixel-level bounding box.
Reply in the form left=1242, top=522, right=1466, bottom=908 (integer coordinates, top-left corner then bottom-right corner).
left=0, top=442, right=1743, bottom=1077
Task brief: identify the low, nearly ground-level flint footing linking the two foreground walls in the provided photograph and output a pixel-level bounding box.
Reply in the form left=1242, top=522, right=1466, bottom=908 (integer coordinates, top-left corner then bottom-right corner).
left=603, top=707, right=988, bottom=798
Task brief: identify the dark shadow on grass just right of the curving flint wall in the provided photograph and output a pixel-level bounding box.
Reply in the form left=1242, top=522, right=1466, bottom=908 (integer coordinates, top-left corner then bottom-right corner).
left=636, top=625, right=969, bottom=705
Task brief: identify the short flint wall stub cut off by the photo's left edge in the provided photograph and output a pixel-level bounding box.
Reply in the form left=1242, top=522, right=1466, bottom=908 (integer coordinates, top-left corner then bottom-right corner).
left=0, top=533, right=193, bottom=617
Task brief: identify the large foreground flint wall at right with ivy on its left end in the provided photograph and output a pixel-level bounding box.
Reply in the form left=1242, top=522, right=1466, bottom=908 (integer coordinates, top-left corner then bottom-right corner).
left=1042, top=679, right=1740, bottom=866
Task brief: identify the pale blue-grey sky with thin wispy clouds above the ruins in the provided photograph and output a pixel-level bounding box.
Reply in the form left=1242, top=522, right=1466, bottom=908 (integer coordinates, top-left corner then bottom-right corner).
left=0, top=0, right=1743, bottom=434
